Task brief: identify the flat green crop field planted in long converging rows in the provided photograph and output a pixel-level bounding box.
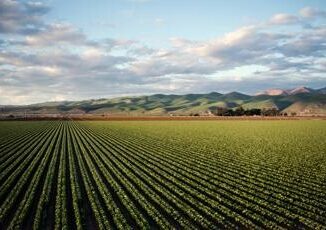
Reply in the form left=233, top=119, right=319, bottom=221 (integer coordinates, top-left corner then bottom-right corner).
left=0, top=120, right=326, bottom=229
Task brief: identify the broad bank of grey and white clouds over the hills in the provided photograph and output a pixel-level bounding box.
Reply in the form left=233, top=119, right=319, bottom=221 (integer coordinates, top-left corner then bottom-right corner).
left=0, top=0, right=326, bottom=104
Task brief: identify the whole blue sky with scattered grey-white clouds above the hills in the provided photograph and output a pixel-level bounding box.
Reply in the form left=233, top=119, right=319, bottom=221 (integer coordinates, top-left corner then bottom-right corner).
left=0, top=0, right=326, bottom=105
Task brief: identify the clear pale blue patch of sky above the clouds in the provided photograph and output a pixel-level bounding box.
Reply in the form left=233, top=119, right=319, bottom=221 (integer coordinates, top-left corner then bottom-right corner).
left=49, top=0, right=326, bottom=43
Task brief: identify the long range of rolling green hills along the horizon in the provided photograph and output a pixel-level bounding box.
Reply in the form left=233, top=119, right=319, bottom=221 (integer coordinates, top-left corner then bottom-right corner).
left=0, top=87, right=326, bottom=116
